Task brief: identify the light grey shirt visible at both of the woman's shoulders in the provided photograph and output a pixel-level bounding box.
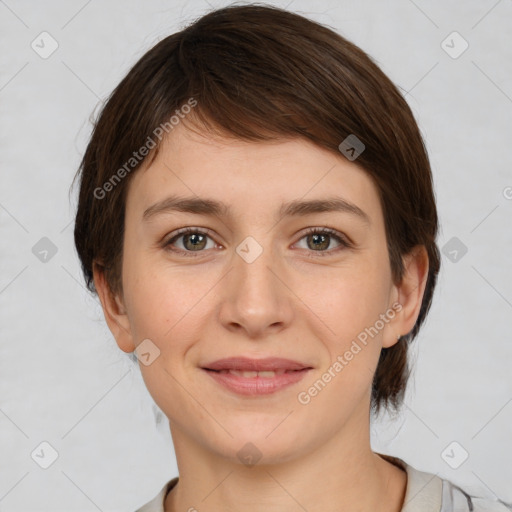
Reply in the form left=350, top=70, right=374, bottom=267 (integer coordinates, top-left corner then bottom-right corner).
left=135, top=453, right=512, bottom=512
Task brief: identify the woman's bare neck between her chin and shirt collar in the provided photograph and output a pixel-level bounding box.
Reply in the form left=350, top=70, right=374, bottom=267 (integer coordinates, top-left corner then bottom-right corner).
left=165, top=402, right=407, bottom=512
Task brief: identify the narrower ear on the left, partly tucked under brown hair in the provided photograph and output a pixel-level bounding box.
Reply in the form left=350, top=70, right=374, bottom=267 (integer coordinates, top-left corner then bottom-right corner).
left=93, top=261, right=136, bottom=352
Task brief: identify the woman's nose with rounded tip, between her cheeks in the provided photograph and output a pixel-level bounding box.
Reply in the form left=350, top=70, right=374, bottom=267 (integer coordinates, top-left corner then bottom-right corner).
left=219, top=238, right=293, bottom=339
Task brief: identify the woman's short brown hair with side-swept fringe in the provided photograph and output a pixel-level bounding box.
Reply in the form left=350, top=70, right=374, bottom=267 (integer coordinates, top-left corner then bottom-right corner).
left=73, top=4, right=440, bottom=414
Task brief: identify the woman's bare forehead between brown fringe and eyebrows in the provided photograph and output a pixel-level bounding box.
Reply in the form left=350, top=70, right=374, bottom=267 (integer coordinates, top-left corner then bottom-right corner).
left=126, top=124, right=381, bottom=225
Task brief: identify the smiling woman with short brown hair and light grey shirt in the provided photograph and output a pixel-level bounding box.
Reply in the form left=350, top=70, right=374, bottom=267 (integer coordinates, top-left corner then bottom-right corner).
left=75, top=5, right=510, bottom=512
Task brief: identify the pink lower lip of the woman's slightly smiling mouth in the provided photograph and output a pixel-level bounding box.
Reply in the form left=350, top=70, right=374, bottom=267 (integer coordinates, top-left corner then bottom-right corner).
left=204, top=368, right=310, bottom=396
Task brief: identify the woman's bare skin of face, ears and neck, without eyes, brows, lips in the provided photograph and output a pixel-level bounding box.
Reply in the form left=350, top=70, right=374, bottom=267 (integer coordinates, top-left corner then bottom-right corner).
left=94, top=123, right=428, bottom=512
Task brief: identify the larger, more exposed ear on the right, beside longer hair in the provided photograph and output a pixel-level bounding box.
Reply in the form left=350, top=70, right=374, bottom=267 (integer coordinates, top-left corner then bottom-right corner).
left=382, top=245, right=429, bottom=348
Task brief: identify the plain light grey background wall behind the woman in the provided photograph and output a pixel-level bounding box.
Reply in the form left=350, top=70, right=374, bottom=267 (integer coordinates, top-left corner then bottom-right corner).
left=0, top=0, right=512, bottom=511
